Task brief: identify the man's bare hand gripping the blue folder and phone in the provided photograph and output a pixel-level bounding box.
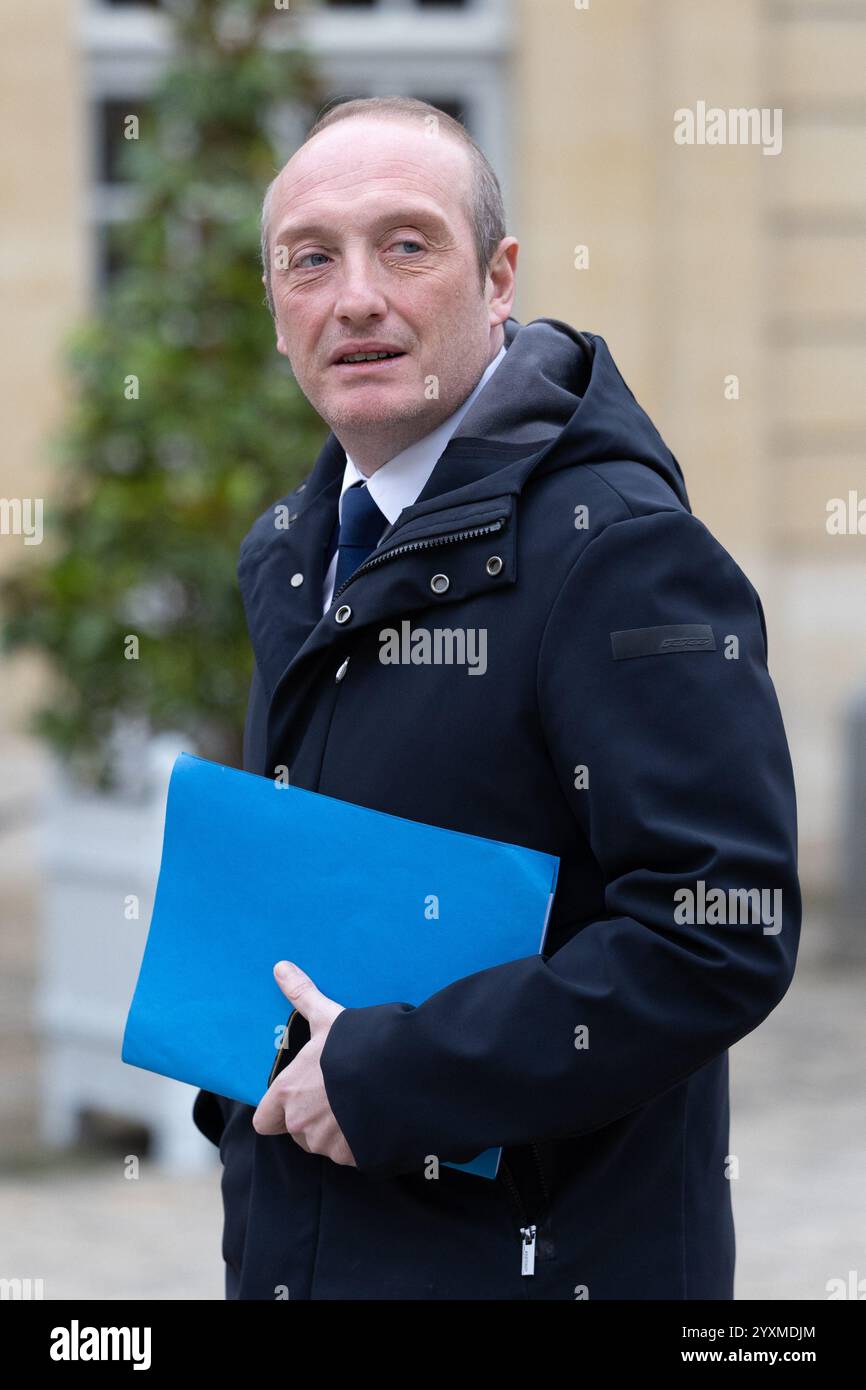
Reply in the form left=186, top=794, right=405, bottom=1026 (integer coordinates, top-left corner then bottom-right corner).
left=253, top=960, right=357, bottom=1168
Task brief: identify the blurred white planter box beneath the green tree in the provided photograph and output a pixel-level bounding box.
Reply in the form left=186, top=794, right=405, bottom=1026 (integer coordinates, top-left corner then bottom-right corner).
left=35, top=735, right=218, bottom=1173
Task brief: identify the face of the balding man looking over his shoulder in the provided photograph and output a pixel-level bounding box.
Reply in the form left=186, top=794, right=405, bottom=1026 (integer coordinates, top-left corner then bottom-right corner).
left=270, top=117, right=516, bottom=461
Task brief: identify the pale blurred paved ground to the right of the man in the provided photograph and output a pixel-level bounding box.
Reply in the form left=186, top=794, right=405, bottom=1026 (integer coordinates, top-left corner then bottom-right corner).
left=731, top=970, right=866, bottom=1298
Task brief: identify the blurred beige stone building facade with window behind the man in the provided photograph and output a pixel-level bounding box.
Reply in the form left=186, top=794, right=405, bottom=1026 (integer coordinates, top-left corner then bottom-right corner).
left=0, top=0, right=866, bottom=920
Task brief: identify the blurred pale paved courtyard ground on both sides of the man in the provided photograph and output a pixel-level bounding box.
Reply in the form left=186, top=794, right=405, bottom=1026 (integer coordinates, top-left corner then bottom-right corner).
left=0, top=906, right=866, bottom=1300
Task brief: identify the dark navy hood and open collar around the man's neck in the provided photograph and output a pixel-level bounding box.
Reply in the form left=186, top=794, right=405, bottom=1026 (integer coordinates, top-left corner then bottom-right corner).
left=238, top=318, right=691, bottom=706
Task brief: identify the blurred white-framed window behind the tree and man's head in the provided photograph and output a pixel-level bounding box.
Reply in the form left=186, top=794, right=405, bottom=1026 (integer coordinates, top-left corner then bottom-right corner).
left=81, top=0, right=512, bottom=292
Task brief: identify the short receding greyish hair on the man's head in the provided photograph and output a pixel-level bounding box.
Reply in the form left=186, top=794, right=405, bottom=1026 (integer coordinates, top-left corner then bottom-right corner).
left=261, top=96, right=506, bottom=317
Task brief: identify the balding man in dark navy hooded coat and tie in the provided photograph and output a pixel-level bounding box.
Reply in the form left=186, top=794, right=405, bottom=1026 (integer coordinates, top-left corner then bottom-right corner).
left=195, top=99, right=801, bottom=1300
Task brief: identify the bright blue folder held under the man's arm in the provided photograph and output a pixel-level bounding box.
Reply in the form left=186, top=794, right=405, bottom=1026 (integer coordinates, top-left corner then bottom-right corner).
left=121, top=753, right=559, bottom=1177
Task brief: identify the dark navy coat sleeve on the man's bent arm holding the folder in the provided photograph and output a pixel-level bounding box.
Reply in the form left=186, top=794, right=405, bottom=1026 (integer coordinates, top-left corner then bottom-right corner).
left=315, top=512, right=801, bottom=1173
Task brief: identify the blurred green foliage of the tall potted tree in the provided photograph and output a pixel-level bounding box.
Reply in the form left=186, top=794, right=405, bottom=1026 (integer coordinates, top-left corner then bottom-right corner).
left=3, top=0, right=324, bottom=787
